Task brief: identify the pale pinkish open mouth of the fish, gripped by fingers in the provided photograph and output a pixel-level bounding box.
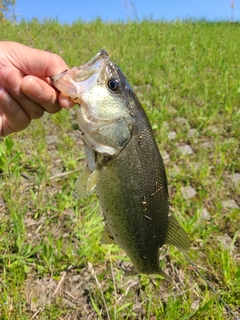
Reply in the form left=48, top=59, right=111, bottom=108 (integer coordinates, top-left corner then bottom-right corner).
left=51, top=49, right=109, bottom=100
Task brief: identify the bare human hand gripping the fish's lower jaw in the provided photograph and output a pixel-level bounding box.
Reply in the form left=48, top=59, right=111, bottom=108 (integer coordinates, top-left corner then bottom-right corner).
left=0, top=41, right=74, bottom=136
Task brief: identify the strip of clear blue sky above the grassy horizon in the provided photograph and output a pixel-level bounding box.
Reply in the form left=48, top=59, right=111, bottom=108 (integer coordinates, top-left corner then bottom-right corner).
left=10, top=0, right=240, bottom=24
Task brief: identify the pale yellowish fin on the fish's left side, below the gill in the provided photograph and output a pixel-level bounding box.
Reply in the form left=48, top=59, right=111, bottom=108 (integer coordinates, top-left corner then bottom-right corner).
left=75, top=167, right=101, bottom=199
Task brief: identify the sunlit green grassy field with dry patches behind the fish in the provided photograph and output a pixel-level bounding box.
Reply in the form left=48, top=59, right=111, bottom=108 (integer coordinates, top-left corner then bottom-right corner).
left=0, top=20, right=240, bottom=320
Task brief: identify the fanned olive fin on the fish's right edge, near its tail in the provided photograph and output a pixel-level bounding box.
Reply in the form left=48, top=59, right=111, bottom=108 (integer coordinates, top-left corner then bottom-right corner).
left=165, top=216, right=190, bottom=250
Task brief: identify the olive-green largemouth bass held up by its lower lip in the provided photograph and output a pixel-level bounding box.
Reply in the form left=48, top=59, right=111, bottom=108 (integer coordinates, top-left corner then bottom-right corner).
left=51, top=49, right=190, bottom=274
